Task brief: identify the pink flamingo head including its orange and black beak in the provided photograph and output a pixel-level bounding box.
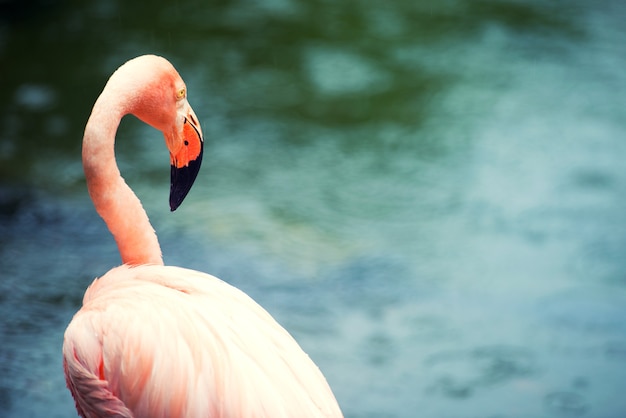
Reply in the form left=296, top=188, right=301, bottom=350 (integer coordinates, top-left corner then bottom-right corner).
left=120, top=55, right=204, bottom=211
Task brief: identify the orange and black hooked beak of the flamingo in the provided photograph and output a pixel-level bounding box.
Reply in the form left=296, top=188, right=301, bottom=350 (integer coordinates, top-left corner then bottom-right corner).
left=166, top=106, right=204, bottom=212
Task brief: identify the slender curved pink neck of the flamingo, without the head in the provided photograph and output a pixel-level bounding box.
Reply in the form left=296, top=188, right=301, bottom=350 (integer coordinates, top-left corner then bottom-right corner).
left=83, top=87, right=163, bottom=265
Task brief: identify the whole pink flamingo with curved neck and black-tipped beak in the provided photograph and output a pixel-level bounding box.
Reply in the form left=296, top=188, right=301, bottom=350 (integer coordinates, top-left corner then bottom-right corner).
left=63, top=55, right=342, bottom=418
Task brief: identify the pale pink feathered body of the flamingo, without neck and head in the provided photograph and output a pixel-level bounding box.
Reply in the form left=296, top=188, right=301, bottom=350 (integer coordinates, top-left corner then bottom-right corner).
left=63, top=266, right=337, bottom=418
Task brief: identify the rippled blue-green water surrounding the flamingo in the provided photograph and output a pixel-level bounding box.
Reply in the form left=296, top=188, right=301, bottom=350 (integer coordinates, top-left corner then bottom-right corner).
left=0, top=0, right=626, bottom=418
